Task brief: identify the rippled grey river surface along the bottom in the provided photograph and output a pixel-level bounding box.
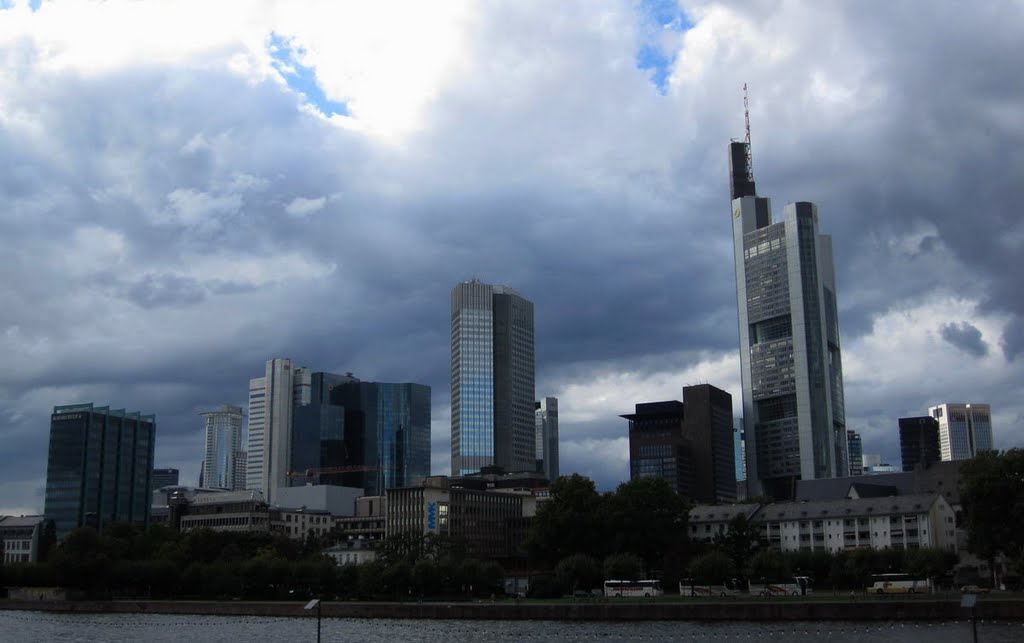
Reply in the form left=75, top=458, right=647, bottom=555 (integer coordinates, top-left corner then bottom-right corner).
left=0, top=611, right=1024, bottom=643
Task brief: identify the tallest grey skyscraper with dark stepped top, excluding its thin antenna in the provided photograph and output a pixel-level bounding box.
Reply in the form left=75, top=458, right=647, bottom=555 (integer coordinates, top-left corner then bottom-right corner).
left=729, top=142, right=849, bottom=499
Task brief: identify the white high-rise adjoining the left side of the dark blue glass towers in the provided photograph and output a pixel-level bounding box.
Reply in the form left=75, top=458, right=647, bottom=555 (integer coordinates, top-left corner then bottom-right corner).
left=246, top=357, right=310, bottom=504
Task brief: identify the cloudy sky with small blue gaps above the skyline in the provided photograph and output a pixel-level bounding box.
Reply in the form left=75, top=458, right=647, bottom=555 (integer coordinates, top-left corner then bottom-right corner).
left=0, top=0, right=1024, bottom=514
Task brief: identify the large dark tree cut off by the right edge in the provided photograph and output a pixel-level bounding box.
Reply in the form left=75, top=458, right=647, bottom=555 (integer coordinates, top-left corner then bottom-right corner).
left=959, top=448, right=1024, bottom=582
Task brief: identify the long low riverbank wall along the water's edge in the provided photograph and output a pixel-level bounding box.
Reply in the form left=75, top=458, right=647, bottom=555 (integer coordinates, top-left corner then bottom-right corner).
left=0, top=597, right=1024, bottom=620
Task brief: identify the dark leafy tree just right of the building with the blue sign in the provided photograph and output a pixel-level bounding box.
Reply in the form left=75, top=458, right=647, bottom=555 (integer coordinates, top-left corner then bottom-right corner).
left=523, top=473, right=610, bottom=565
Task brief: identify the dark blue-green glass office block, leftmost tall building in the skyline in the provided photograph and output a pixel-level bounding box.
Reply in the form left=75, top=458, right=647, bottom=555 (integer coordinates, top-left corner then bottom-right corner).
left=44, top=403, right=157, bottom=539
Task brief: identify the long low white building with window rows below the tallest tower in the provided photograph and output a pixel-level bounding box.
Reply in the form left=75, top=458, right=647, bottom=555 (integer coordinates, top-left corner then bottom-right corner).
left=689, top=494, right=957, bottom=553
